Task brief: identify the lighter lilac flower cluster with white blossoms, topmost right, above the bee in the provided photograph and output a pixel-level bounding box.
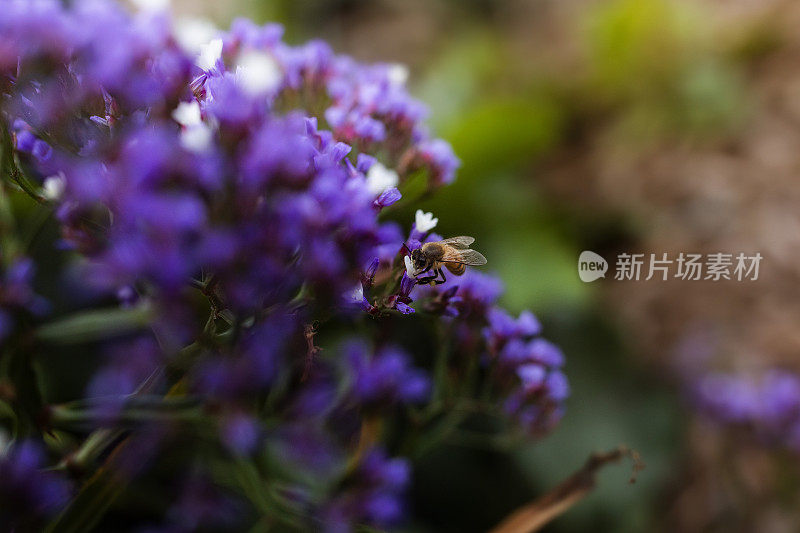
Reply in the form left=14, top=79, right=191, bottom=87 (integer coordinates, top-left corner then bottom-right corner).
left=217, top=20, right=458, bottom=192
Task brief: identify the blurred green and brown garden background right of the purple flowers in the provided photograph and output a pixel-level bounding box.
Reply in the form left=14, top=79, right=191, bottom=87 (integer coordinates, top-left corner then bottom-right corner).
left=162, top=0, right=800, bottom=532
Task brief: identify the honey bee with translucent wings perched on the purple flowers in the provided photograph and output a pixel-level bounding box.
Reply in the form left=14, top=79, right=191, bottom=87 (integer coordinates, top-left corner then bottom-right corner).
left=409, top=236, right=486, bottom=285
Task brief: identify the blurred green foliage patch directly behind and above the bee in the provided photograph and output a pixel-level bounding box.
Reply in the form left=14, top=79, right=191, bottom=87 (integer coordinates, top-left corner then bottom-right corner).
left=410, top=33, right=586, bottom=311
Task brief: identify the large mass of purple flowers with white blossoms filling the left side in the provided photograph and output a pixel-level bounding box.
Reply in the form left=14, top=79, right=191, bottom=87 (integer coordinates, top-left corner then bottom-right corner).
left=0, top=0, right=568, bottom=531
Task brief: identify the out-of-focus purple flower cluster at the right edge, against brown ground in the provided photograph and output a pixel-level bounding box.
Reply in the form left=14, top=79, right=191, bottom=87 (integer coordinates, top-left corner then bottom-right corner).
left=693, top=370, right=800, bottom=451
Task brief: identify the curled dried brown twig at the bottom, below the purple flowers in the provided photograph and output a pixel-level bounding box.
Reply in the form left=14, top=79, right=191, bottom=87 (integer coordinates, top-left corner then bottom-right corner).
left=491, top=446, right=644, bottom=533
